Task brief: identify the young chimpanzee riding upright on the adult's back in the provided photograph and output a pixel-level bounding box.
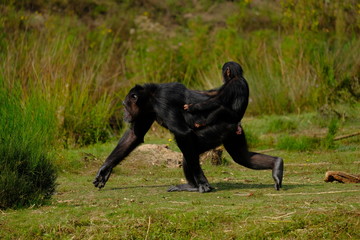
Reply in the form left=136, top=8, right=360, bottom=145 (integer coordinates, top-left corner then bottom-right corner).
left=184, top=62, right=249, bottom=134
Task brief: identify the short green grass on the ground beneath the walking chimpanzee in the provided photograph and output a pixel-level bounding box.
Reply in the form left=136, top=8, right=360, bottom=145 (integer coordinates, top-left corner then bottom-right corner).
left=0, top=113, right=360, bottom=239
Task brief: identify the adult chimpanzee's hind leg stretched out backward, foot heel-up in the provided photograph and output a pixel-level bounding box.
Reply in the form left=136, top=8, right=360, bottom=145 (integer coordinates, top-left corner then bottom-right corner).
left=224, top=128, right=284, bottom=190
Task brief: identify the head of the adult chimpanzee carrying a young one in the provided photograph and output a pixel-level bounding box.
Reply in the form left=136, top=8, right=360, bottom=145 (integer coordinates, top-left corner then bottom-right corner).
left=123, top=85, right=151, bottom=123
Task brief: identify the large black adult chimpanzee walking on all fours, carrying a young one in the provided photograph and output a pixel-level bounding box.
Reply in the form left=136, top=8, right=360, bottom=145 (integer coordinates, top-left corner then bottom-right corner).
left=93, top=83, right=283, bottom=192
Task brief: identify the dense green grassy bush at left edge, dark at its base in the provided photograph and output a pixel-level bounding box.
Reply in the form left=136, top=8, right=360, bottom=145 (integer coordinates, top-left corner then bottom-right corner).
left=0, top=83, right=56, bottom=208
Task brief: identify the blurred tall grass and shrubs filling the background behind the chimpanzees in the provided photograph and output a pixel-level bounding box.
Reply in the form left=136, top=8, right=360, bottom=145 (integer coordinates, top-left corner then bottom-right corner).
left=0, top=0, right=360, bottom=207
